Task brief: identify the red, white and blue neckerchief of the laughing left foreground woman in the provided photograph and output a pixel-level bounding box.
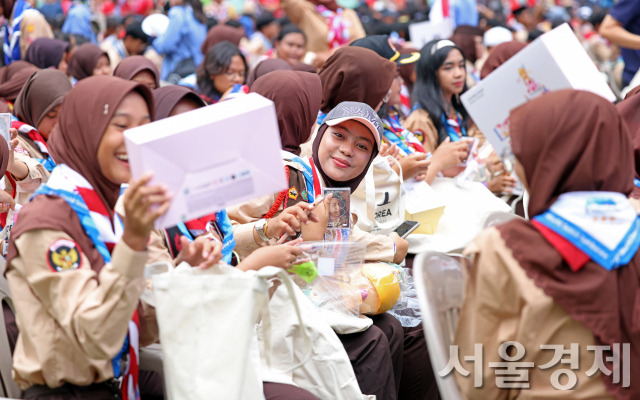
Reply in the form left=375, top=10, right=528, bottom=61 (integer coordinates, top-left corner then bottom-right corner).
left=34, top=164, right=140, bottom=400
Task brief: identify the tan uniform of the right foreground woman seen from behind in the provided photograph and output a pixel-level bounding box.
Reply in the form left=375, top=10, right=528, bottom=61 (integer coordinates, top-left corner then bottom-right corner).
left=452, top=228, right=614, bottom=400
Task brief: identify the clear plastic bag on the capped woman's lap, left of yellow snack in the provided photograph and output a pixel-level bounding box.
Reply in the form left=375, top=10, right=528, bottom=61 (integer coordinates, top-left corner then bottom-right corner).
left=293, top=242, right=366, bottom=317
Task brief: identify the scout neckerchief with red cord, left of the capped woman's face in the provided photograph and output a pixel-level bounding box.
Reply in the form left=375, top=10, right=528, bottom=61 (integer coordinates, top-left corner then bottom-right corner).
left=263, top=154, right=317, bottom=218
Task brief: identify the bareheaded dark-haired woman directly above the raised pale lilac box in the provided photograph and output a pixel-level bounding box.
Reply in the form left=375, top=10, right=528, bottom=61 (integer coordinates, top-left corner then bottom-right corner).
left=196, top=41, right=248, bottom=104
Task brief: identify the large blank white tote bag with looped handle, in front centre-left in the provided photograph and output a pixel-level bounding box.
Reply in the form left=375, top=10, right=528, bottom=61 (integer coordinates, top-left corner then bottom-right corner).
left=153, top=263, right=311, bottom=400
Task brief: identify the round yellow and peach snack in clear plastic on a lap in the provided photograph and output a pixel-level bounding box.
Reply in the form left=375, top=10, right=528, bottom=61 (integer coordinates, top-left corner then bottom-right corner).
left=360, top=263, right=401, bottom=315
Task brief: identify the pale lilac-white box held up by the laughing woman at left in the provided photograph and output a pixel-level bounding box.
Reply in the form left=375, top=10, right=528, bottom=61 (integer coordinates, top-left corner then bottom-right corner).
left=124, top=93, right=287, bottom=228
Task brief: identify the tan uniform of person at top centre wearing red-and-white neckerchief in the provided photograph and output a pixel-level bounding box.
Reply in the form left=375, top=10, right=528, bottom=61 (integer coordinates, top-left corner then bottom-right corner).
left=280, top=0, right=366, bottom=53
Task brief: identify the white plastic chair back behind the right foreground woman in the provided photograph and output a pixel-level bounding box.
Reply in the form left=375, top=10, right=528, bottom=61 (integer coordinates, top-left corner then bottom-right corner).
left=413, top=252, right=469, bottom=400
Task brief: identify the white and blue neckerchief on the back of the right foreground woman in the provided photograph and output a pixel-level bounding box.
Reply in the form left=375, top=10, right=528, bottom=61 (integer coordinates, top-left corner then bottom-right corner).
left=533, top=192, right=640, bottom=270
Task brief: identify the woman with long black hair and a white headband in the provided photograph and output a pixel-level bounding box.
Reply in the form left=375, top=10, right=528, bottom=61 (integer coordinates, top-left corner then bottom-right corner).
left=403, top=40, right=504, bottom=188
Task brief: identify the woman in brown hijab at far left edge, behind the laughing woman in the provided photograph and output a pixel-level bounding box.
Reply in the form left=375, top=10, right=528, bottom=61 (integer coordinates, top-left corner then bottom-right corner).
left=5, top=69, right=71, bottom=225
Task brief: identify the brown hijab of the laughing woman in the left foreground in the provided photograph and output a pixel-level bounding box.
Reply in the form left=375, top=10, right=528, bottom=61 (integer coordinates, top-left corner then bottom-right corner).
left=49, top=76, right=153, bottom=210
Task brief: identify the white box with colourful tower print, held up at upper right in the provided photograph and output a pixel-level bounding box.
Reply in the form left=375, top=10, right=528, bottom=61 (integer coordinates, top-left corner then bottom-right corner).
left=461, top=24, right=615, bottom=156
